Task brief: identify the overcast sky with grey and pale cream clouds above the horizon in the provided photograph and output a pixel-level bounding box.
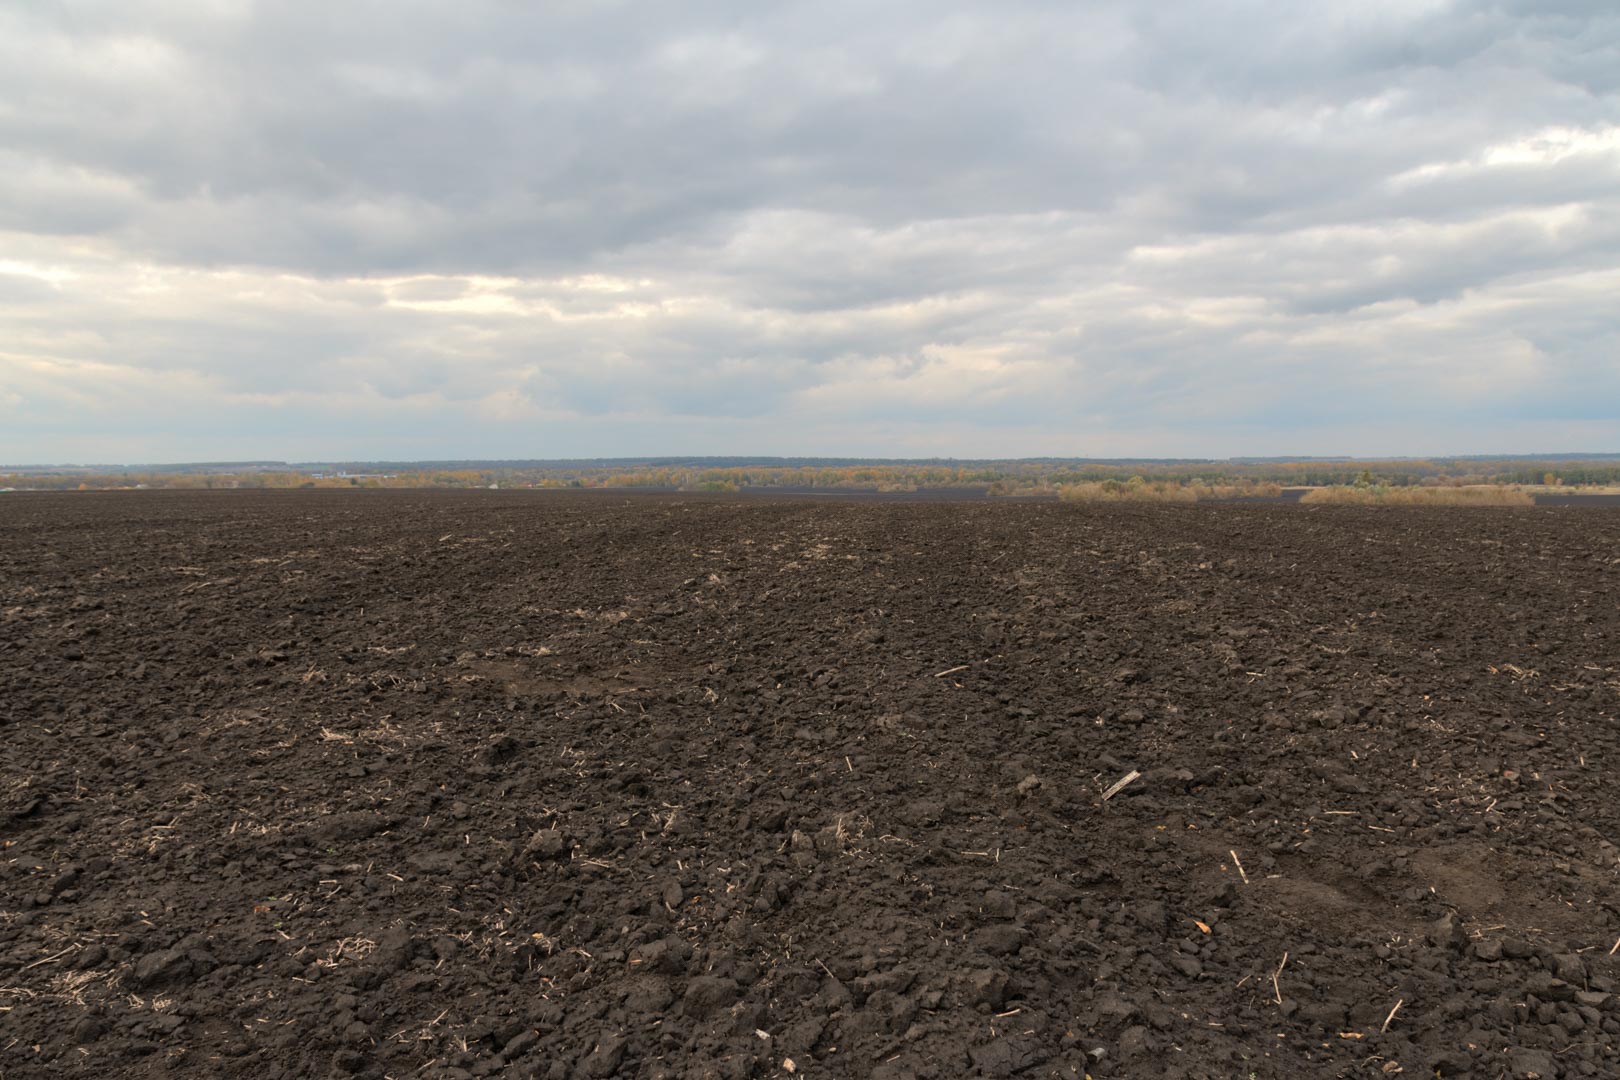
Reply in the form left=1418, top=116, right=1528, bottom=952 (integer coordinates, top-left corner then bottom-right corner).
left=0, top=0, right=1620, bottom=465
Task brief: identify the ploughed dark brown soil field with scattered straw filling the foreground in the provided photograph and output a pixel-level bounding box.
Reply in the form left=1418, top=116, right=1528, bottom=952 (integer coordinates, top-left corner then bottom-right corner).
left=0, top=492, right=1620, bottom=1080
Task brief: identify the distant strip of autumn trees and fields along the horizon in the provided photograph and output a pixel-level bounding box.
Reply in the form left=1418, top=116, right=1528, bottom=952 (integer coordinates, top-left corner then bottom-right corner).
left=0, top=453, right=1620, bottom=495
